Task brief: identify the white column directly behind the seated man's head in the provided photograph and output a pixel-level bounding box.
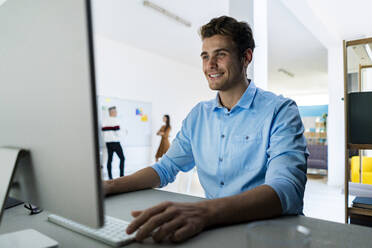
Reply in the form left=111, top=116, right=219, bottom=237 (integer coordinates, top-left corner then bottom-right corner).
left=229, top=0, right=268, bottom=89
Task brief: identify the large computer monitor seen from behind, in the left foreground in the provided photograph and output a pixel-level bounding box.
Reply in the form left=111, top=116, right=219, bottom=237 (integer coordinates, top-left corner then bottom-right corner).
left=0, top=0, right=103, bottom=227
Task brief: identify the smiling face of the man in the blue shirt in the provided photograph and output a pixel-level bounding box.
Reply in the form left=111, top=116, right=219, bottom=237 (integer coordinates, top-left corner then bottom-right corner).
left=200, top=35, right=246, bottom=91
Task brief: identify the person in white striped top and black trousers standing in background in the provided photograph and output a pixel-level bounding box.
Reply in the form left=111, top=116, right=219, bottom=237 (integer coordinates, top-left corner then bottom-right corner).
left=102, top=106, right=125, bottom=179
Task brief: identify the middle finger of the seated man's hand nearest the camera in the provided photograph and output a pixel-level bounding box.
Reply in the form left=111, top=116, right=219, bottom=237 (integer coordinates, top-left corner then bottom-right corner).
left=136, top=208, right=178, bottom=241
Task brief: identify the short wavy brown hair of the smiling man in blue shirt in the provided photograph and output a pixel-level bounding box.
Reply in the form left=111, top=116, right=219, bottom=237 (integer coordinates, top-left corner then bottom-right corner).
left=199, top=16, right=255, bottom=56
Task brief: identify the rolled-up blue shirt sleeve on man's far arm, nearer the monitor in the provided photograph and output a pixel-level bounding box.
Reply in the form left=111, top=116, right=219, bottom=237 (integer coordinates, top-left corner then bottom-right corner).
left=152, top=112, right=195, bottom=187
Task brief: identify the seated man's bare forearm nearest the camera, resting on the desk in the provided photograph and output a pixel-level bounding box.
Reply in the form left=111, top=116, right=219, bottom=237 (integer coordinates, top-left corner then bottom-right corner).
left=201, top=185, right=282, bottom=226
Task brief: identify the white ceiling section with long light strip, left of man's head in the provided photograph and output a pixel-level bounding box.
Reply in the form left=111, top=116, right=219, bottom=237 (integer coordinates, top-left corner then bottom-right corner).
left=93, top=0, right=228, bottom=68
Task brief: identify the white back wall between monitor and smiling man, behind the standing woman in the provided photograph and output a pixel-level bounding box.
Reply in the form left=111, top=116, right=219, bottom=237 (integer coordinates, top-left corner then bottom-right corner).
left=95, top=34, right=216, bottom=190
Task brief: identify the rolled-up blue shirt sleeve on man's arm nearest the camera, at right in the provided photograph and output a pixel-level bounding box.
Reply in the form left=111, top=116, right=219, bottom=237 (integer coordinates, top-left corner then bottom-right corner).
left=265, top=99, right=309, bottom=215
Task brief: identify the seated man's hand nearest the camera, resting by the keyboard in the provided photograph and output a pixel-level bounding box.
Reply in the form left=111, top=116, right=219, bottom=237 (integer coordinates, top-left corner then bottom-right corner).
left=127, top=201, right=211, bottom=242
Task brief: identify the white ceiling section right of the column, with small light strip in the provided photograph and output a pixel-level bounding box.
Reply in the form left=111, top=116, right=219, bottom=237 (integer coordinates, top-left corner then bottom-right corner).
left=268, top=0, right=328, bottom=95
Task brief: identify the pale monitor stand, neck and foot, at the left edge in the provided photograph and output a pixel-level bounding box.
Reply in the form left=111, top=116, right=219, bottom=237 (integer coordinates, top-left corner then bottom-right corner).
left=0, top=147, right=58, bottom=248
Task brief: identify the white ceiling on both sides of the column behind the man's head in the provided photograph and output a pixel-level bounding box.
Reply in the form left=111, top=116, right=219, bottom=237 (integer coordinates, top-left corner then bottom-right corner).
left=93, top=0, right=372, bottom=95
